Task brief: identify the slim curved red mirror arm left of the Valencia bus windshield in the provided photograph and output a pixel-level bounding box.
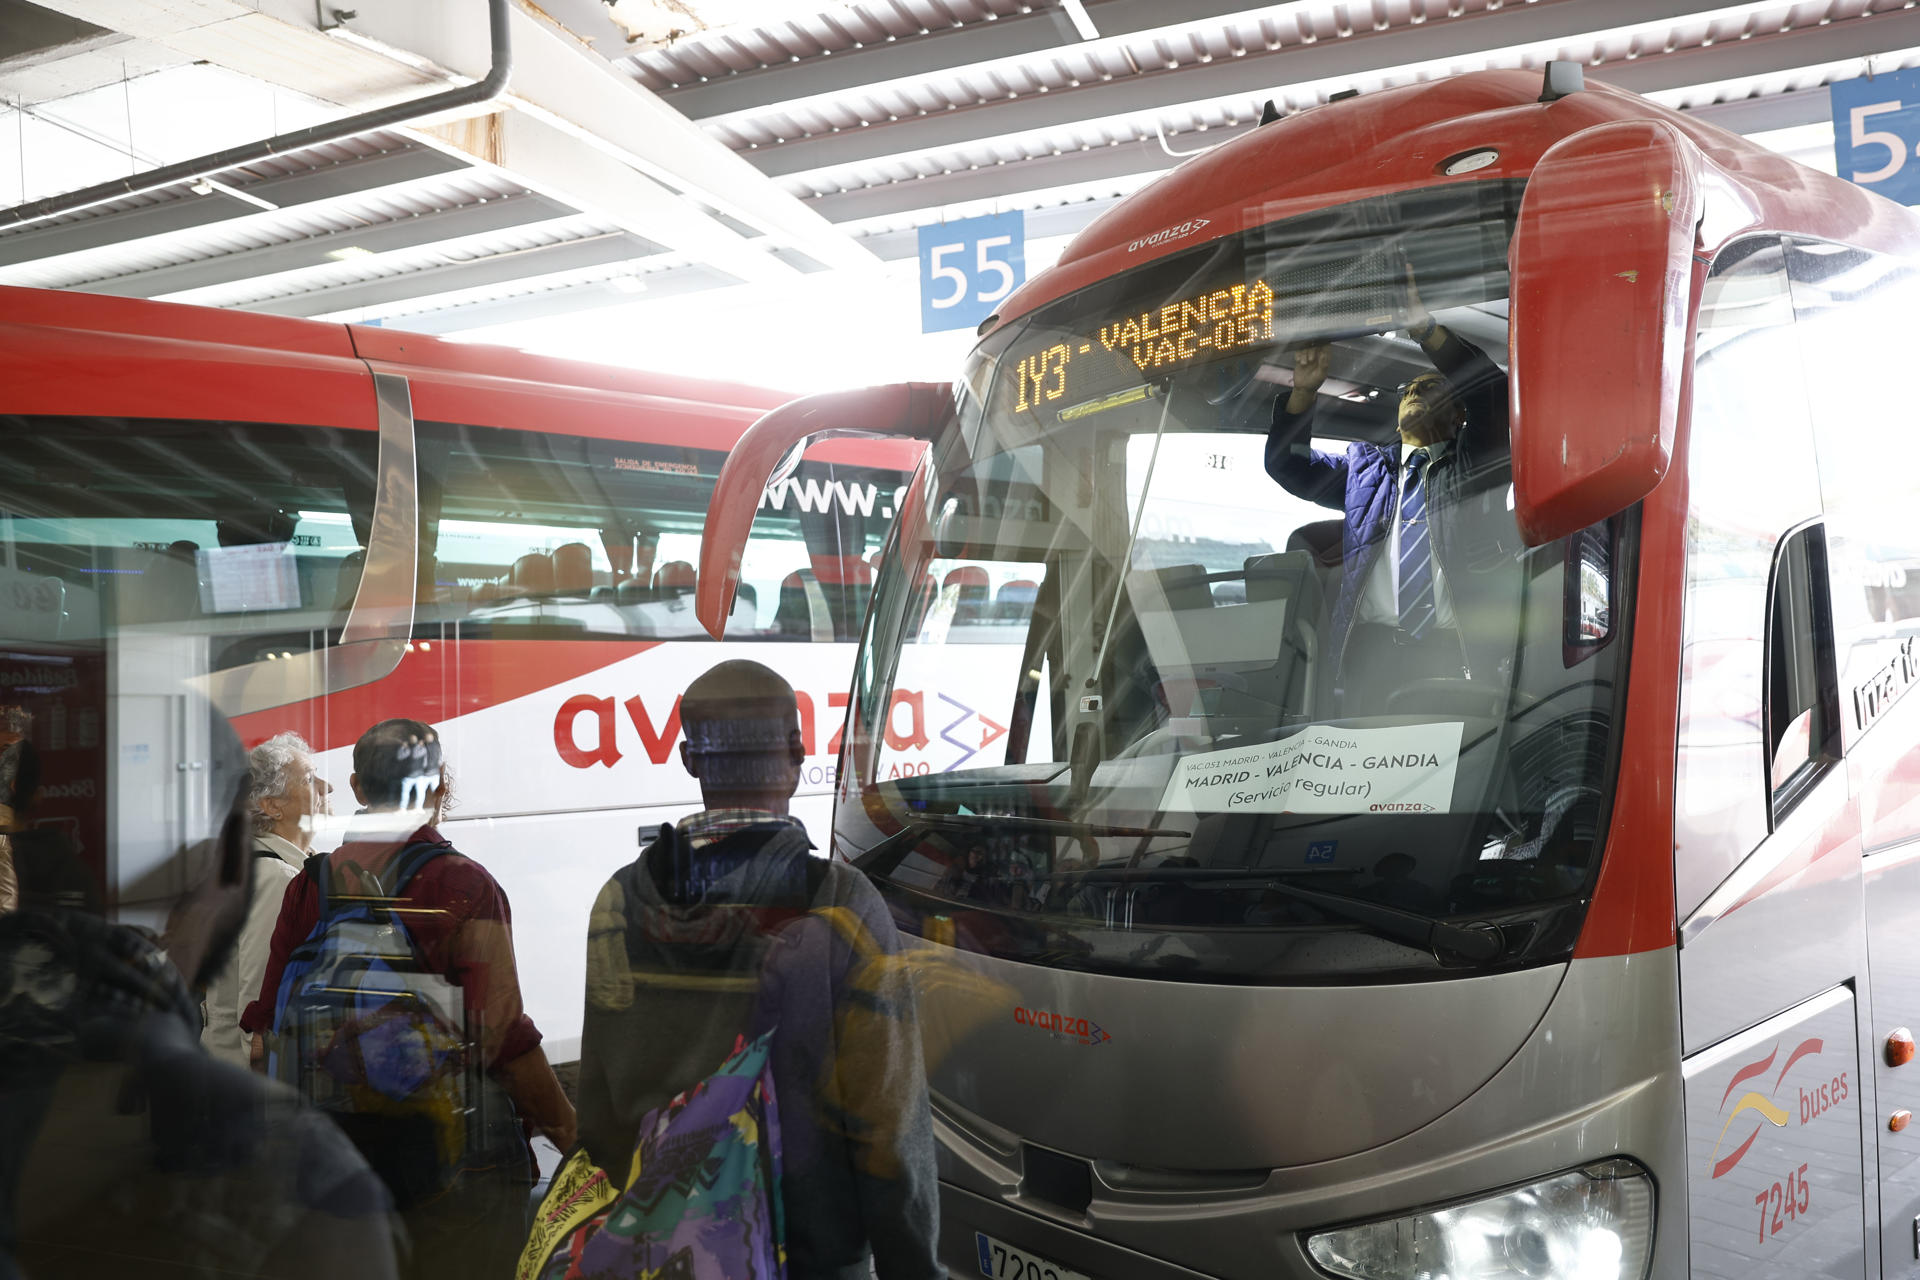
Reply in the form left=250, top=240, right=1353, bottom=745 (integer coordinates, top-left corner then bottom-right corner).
left=693, top=382, right=954, bottom=639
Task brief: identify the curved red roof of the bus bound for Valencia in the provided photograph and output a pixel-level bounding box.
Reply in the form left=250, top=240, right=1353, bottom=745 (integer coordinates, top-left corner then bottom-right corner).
left=998, top=71, right=1920, bottom=335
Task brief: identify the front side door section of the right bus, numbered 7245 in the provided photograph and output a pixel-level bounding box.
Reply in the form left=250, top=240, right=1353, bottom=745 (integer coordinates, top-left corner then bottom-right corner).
left=1674, top=238, right=1872, bottom=1280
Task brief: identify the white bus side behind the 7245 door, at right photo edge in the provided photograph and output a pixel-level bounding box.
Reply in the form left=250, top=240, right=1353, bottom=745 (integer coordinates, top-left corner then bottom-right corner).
left=1788, top=235, right=1920, bottom=1276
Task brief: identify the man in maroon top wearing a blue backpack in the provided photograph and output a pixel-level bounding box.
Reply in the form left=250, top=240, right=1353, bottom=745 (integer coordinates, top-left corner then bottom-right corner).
left=242, top=720, right=574, bottom=1280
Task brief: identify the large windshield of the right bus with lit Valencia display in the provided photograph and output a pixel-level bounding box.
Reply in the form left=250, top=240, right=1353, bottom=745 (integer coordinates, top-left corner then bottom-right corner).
left=835, top=180, right=1634, bottom=981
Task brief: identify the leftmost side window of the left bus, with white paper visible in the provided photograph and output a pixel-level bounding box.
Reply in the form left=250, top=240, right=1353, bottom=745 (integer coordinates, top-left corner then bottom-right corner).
left=0, top=416, right=378, bottom=670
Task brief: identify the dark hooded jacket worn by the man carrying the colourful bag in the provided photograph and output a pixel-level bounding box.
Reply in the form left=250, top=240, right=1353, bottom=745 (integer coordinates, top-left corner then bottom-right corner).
left=578, top=823, right=943, bottom=1280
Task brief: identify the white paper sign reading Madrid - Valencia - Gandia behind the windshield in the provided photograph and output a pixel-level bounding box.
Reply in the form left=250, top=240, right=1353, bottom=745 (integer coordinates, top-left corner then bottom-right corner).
left=1160, top=722, right=1465, bottom=814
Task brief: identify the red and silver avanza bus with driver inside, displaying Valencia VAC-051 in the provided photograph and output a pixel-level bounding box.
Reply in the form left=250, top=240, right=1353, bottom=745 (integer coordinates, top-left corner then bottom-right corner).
left=699, top=65, right=1920, bottom=1280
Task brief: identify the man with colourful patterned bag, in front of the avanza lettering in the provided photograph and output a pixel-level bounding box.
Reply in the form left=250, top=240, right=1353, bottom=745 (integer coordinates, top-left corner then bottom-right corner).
left=518, top=662, right=943, bottom=1280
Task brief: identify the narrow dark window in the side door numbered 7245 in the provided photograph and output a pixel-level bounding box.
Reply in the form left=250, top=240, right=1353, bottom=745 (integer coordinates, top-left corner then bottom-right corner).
left=1766, top=524, right=1839, bottom=827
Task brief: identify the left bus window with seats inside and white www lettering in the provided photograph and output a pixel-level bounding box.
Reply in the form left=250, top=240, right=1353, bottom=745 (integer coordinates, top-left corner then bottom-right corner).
left=417, top=422, right=904, bottom=643
